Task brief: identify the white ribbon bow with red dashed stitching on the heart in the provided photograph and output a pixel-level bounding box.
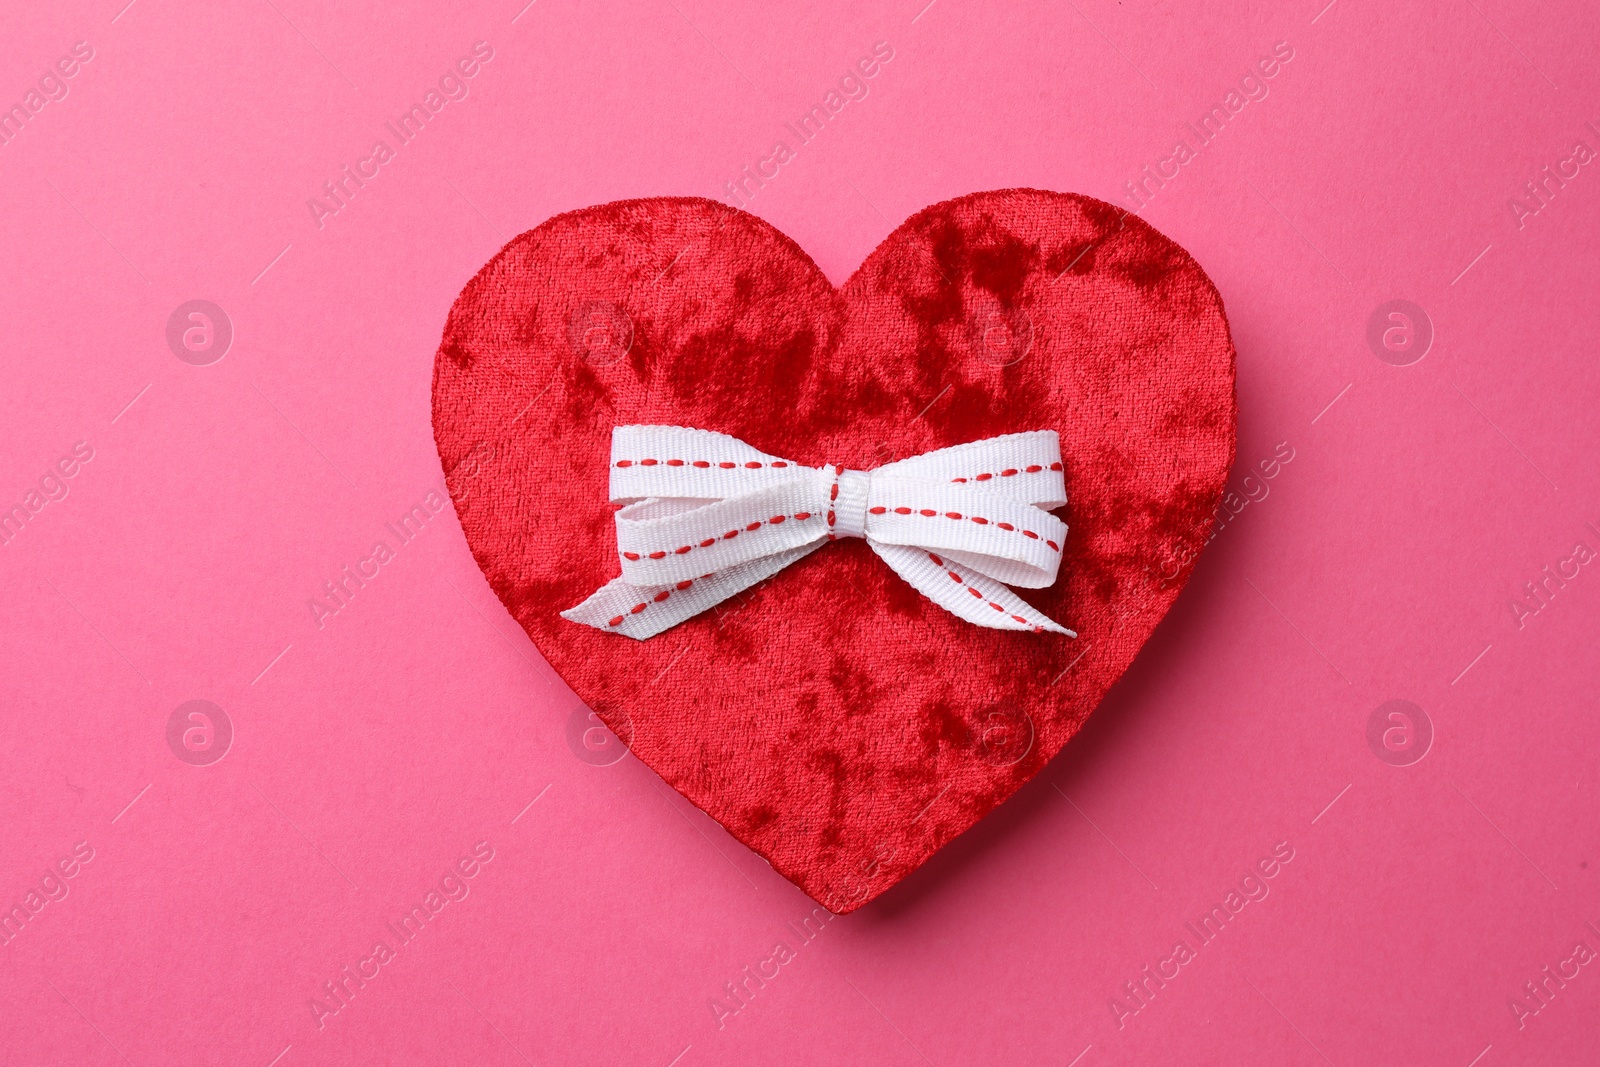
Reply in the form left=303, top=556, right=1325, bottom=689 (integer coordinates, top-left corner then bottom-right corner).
left=562, top=426, right=1077, bottom=640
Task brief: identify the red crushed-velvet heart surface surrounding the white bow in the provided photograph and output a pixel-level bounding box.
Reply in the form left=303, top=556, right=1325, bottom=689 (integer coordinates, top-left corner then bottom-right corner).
left=434, top=189, right=1234, bottom=912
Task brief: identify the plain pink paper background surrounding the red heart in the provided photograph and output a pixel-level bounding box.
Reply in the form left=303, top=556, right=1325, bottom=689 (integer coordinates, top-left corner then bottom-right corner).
left=0, top=0, right=1600, bottom=1067
